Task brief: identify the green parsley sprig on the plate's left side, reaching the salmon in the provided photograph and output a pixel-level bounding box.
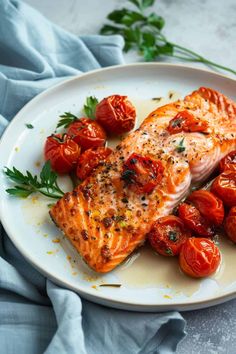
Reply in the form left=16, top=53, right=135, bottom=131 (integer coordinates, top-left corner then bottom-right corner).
left=4, top=161, right=64, bottom=199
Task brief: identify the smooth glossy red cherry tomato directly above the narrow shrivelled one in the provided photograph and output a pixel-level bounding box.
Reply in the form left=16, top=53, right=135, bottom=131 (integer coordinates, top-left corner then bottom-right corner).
left=188, top=189, right=224, bottom=226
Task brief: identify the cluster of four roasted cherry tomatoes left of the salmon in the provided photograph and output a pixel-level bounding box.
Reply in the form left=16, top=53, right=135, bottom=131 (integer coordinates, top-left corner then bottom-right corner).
left=44, top=95, right=136, bottom=180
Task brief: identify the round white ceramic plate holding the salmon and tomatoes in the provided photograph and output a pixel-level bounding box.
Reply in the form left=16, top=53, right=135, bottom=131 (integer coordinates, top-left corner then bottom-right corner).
left=0, top=64, right=236, bottom=311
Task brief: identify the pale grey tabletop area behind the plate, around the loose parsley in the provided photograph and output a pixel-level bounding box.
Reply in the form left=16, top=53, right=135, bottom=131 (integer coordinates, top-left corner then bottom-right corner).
left=25, top=0, right=236, bottom=74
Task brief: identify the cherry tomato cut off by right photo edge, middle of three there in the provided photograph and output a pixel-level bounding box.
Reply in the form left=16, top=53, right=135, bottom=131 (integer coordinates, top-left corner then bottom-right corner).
left=211, top=170, right=236, bottom=207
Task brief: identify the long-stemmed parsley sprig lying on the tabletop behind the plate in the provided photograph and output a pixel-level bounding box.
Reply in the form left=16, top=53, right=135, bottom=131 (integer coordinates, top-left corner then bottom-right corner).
left=100, top=0, right=236, bottom=75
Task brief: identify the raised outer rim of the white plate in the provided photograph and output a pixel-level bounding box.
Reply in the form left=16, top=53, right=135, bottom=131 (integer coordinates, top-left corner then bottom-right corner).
left=0, top=63, right=236, bottom=311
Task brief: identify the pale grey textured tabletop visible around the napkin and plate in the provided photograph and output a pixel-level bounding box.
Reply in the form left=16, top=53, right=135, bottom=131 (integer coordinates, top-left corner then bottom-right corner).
left=25, top=0, right=236, bottom=354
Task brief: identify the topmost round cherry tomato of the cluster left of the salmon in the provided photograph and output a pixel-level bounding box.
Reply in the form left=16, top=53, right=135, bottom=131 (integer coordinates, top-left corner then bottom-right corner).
left=96, top=95, right=136, bottom=134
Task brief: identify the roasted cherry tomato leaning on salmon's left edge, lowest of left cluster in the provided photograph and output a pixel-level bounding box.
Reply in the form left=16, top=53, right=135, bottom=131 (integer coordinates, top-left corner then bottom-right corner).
left=76, top=147, right=112, bottom=181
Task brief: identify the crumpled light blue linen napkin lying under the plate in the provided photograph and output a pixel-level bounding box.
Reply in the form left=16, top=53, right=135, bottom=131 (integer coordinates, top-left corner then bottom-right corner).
left=0, top=0, right=185, bottom=354
